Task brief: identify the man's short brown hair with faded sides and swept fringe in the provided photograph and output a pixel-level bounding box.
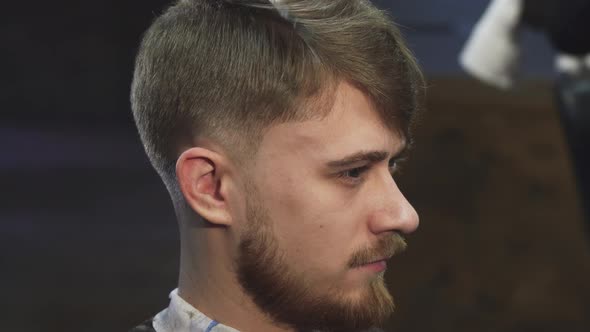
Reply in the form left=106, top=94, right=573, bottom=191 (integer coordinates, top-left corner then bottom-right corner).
left=131, top=0, right=424, bottom=195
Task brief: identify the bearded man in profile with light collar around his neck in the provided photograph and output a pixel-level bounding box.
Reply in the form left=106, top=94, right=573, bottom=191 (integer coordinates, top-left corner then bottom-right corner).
left=131, top=0, right=423, bottom=332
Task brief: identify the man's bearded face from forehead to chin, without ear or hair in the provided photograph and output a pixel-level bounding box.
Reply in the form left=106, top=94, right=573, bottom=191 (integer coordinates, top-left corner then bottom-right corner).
left=237, top=83, right=418, bottom=331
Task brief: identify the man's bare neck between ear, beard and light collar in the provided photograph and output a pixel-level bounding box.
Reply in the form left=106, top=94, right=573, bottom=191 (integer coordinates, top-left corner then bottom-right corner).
left=178, top=229, right=293, bottom=332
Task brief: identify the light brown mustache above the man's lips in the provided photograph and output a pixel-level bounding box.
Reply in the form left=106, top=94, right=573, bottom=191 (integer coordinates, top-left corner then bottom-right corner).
left=348, top=233, right=408, bottom=268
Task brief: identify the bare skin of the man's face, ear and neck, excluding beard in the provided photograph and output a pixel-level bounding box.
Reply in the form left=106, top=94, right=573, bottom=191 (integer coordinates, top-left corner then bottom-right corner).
left=177, top=82, right=418, bottom=331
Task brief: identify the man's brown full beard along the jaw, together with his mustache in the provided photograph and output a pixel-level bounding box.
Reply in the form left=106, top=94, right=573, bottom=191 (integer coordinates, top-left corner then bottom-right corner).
left=236, top=185, right=406, bottom=332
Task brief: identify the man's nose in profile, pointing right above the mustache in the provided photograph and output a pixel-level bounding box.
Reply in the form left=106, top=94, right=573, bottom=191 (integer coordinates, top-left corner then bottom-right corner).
left=370, top=174, right=419, bottom=234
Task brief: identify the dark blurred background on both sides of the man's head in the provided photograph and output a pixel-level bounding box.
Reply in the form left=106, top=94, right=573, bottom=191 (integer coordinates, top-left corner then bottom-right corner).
left=0, top=0, right=590, bottom=332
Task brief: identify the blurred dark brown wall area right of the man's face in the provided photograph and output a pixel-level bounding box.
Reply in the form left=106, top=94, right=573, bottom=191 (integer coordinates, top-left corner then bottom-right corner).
left=387, top=78, right=590, bottom=331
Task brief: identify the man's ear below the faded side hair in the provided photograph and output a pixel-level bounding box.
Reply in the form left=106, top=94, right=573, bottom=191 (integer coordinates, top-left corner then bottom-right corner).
left=176, top=147, right=232, bottom=226
